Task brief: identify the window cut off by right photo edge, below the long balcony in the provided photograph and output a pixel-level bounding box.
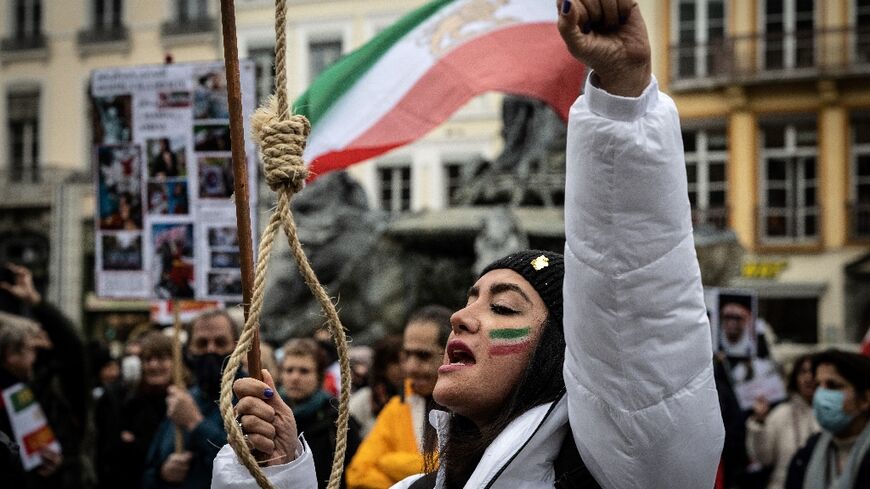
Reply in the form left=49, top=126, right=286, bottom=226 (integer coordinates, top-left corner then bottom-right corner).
left=851, top=113, right=870, bottom=238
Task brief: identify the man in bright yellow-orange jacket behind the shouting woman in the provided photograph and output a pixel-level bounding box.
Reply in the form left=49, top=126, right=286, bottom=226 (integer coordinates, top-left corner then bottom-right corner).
left=347, top=305, right=451, bottom=489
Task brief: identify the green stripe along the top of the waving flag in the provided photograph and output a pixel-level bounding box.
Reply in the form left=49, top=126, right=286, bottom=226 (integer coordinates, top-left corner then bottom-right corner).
left=293, top=0, right=454, bottom=126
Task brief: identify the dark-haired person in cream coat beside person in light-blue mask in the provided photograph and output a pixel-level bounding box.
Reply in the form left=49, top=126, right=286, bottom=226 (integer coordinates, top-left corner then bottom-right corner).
left=746, top=355, right=819, bottom=489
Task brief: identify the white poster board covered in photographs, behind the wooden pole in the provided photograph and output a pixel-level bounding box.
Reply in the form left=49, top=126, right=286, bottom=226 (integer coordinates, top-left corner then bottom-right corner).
left=90, top=61, right=257, bottom=301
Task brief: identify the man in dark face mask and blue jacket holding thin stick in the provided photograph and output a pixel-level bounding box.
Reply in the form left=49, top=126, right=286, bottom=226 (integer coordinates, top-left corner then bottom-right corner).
left=142, top=310, right=238, bottom=489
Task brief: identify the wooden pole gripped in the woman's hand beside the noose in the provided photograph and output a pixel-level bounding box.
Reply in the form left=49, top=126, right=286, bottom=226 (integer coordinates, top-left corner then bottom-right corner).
left=221, top=0, right=263, bottom=380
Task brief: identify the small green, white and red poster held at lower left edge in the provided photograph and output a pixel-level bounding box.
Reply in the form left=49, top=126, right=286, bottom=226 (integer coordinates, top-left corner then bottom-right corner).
left=3, top=382, right=61, bottom=471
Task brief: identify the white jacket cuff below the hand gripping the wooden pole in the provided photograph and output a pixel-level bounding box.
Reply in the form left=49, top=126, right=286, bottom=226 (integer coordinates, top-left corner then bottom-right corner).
left=211, top=435, right=317, bottom=489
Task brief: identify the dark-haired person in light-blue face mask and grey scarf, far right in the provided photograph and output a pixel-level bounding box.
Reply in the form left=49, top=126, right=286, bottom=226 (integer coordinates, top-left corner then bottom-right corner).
left=785, top=350, right=870, bottom=489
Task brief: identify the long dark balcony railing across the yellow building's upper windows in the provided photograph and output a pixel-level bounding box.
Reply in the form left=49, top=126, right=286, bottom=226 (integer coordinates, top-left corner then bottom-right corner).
left=670, top=26, right=870, bottom=89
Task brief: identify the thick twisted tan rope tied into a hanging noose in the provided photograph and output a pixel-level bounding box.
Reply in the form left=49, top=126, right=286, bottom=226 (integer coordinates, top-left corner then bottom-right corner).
left=220, top=0, right=351, bottom=489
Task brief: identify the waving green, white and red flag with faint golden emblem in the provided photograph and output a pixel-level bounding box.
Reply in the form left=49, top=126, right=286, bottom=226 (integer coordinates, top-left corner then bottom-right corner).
left=293, top=0, right=584, bottom=175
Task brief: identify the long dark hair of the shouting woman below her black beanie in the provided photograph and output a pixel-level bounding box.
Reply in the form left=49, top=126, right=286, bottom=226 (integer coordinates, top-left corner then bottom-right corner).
left=423, top=317, right=565, bottom=489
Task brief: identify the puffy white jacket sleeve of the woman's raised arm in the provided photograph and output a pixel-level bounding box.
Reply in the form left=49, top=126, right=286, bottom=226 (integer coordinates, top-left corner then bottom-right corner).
left=564, top=73, right=724, bottom=489
